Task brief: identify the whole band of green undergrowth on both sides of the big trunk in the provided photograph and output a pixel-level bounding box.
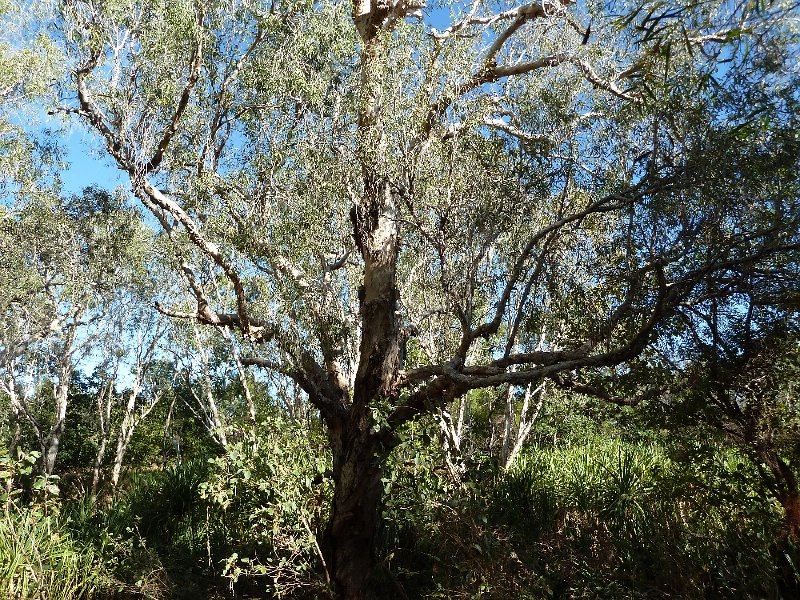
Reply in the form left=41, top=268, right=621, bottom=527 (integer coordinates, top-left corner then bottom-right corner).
left=0, top=403, right=800, bottom=599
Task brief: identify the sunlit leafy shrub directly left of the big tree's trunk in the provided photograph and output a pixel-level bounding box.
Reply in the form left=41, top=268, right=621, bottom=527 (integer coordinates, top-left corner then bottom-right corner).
left=202, top=417, right=332, bottom=597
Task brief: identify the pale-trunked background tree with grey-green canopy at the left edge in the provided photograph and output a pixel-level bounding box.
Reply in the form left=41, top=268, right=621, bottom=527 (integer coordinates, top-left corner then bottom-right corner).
left=0, top=188, right=152, bottom=474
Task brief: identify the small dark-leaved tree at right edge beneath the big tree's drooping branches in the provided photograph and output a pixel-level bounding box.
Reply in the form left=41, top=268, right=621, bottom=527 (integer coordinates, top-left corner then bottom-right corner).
left=667, top=305, right=800, bottom=539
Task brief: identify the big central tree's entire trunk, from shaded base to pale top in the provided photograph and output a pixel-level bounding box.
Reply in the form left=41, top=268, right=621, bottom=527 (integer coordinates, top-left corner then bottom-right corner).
left=323, top=18, right=400, bottom=600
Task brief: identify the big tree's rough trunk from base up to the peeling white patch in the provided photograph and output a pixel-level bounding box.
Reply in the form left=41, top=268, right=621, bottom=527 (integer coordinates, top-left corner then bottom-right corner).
left=324, top=178, right=400, bottom=600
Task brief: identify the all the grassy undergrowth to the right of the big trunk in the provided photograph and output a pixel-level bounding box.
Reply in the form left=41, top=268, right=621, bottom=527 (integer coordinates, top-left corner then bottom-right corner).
left=385, top=437, right=797, bottom=599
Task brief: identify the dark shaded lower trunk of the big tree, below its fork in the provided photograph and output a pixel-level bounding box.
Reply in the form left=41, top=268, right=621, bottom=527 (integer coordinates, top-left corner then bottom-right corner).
left=323, top=423, right=383, bottom=600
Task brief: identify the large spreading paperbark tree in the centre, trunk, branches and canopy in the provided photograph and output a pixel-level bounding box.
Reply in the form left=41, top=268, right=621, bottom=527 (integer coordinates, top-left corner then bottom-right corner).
left=45, top=0, right=798, bottom=598
